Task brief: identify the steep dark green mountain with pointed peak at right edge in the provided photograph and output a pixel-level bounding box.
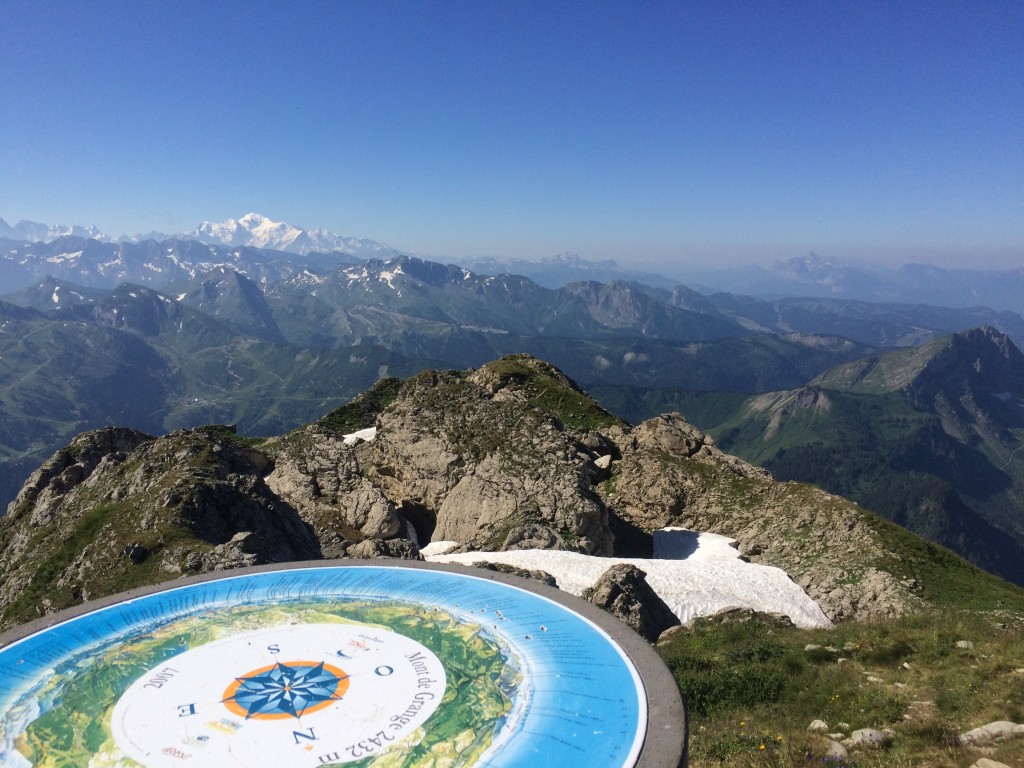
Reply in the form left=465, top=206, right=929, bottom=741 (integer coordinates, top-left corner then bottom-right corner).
left=713, top=328, right=1024, bottom=584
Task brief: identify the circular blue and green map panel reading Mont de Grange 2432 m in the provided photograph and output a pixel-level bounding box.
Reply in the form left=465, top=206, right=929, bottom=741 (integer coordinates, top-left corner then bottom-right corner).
left=0, top=565, right=647, bottom=768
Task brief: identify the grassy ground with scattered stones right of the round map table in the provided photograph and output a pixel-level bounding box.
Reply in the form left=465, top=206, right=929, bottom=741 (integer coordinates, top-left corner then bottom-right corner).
left=658, top=610, right=1024, bottom=768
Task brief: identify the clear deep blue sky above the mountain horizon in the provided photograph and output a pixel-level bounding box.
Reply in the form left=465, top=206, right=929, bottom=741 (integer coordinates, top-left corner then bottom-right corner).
left=0, top=0, right=1024, bottom=266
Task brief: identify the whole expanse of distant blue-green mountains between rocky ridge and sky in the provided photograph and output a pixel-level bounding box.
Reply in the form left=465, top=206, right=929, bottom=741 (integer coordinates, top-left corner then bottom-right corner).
left=0, top=210, right=1024, bottom=583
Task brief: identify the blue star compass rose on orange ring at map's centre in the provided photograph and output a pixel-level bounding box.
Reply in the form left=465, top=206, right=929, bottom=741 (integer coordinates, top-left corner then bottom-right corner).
left=222, top=662, right=349, bottom=720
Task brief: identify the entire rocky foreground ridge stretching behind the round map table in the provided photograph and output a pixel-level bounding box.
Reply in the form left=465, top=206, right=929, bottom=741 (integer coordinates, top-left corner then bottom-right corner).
left=0, top=355, right=1011, bottom=628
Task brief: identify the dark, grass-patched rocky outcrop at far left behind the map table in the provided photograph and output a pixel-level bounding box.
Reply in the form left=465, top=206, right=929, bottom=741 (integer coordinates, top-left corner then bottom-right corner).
left=0, top=428, right=321, bottom=627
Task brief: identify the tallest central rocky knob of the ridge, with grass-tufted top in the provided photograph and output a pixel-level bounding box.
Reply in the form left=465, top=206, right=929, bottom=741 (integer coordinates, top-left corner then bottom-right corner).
left=358, top=361, right=613, bottom=554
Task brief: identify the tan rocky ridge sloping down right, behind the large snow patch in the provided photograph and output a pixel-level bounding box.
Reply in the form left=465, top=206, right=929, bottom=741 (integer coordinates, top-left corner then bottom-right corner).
left=599, top=414, right=922, bottom=622
